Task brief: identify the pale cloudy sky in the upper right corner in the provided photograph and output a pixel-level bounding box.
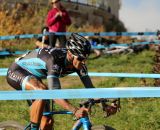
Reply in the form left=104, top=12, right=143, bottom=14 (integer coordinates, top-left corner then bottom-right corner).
left=120, top=0, right=160, bottom=32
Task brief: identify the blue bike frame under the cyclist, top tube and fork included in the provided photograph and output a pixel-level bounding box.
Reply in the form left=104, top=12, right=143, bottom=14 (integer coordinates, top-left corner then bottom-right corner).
left=24, top=111, right=92, bottom=130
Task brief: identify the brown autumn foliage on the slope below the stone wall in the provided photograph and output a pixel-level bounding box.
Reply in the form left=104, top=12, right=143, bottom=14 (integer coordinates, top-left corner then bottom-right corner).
left=0, top=1, right=126, bottom=50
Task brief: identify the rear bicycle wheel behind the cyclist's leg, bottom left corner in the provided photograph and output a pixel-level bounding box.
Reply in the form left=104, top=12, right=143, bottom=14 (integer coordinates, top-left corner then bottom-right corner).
left=0, top=121, right=24, bottom=130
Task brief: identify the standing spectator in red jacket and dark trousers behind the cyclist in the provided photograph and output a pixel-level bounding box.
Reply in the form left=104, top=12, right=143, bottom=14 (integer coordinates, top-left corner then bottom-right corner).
left=46, top=0, right=71, bottom=47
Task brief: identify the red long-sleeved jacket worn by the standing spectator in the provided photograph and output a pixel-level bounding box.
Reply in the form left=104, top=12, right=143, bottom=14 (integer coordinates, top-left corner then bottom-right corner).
left=46, top=8, right=71, bottom=32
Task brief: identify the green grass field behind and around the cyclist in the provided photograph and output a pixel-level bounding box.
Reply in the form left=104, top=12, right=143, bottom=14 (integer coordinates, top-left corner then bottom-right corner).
left=0, top=51, right=160, bottom=130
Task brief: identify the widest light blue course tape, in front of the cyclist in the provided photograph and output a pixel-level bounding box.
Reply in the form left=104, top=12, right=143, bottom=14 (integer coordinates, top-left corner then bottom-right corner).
left=0, top=87, right=160, bottom=100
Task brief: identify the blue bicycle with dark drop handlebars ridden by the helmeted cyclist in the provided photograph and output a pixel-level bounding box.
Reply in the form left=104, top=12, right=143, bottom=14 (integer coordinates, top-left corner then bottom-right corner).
left=0, top=98, right=120, bottom=130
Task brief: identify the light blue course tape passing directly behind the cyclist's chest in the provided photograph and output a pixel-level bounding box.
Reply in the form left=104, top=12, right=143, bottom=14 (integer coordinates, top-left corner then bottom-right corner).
left=0, top=68, right=160, bottom=78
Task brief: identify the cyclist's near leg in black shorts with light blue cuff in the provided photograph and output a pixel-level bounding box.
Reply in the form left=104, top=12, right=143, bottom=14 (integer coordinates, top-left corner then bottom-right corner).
left=7, top=64, right=47, bottom=127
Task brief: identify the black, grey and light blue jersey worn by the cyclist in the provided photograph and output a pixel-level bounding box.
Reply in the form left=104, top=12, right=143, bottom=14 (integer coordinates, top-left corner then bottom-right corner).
left=7, top=47, right=93, bottom=88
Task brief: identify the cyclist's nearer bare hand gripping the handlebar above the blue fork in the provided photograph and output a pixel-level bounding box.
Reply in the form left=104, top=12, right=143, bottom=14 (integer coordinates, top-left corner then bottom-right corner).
left=74, top=107, right=88, bottom=119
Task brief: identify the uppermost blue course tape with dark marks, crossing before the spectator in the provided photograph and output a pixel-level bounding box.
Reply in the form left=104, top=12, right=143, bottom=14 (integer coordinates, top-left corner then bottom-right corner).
left=0, top=31, right=160, bottom=40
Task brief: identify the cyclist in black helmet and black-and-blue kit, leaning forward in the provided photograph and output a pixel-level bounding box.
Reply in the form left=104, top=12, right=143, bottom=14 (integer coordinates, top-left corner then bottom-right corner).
left=7, top=33, right=94, bottom=130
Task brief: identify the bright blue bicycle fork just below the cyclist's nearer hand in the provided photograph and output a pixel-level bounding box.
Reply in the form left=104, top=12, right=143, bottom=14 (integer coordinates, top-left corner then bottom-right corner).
left=72, top=117, right=91, bottom=130
